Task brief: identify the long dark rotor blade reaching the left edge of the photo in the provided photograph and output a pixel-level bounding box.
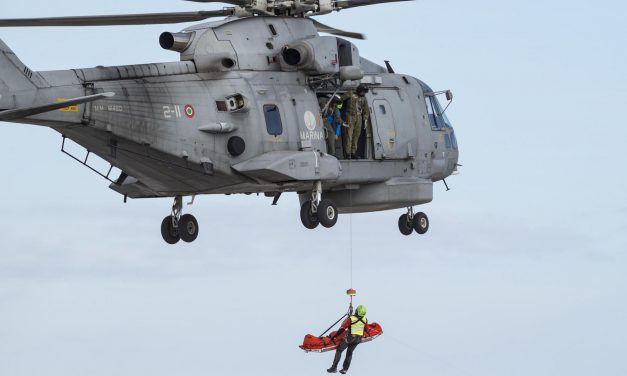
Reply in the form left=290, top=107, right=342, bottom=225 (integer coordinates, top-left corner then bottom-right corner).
left=0, top=8, right=235, bottom=27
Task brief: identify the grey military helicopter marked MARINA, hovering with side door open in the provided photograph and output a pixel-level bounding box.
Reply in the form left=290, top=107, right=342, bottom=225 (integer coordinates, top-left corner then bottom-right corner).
left=0, top=0, right=459, bottom=244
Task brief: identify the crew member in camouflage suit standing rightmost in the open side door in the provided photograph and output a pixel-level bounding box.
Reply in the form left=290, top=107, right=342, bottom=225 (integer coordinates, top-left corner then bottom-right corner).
left=345, top=84, right=370, bottom=159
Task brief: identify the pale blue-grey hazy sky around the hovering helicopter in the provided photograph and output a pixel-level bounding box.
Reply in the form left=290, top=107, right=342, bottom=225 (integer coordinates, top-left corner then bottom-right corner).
left=0, top=0, right=627, bottom=376
